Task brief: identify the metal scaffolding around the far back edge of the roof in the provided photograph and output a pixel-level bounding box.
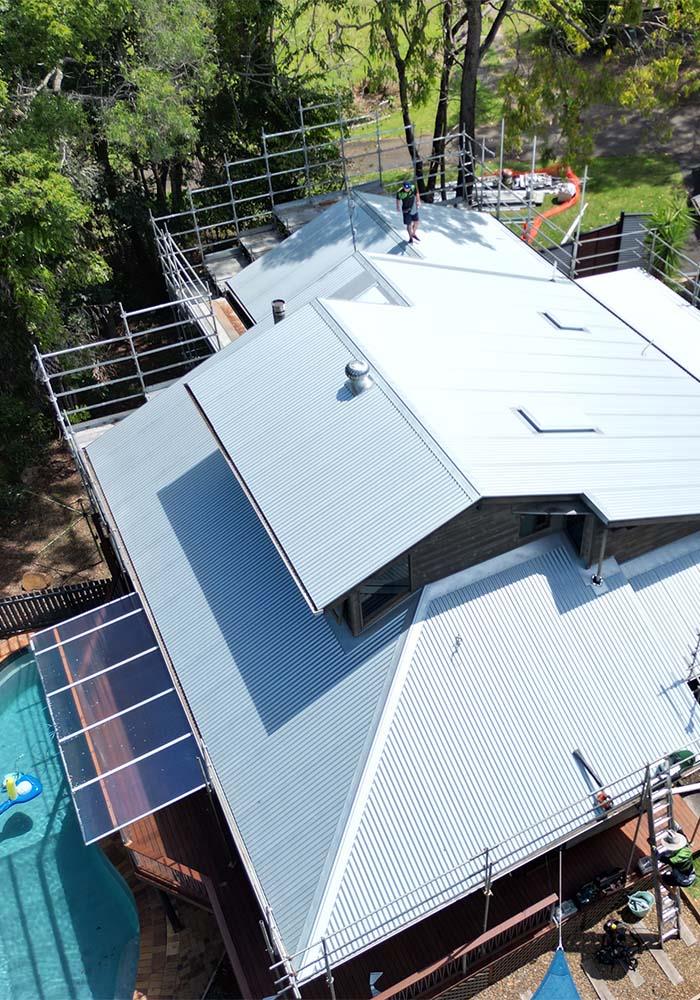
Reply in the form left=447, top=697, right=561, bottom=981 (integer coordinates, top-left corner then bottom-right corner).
left=38, top=101, right=700, bottom=442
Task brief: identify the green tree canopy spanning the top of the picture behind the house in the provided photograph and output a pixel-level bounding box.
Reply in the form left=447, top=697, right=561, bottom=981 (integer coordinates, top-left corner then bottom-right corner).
left=0, top=0, right=700, bottom=500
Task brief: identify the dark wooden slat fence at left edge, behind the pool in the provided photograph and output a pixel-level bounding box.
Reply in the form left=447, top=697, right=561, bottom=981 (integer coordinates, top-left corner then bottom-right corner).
left=0, top=579, right=118, bottom=639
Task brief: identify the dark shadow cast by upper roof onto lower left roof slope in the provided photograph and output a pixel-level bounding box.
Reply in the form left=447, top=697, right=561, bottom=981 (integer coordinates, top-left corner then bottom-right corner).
left=159, top=451, right=412, bottom=734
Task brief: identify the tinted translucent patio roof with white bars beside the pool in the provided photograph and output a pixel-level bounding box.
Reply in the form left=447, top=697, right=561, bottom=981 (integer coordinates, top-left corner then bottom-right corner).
left=32, top=593, right=205, bottom=844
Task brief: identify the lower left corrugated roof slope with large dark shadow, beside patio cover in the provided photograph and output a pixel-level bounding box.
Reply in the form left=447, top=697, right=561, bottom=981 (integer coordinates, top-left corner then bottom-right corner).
left=88, top=376, right=414, bottom=949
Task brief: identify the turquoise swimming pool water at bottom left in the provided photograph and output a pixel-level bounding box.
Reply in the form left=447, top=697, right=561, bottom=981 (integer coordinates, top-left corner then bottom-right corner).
left=0, top=654, right=139, bottom=1000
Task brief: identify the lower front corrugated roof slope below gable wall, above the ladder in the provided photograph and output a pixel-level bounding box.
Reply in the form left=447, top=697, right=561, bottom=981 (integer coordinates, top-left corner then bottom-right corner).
left=314, top=536, right=700, bottom=961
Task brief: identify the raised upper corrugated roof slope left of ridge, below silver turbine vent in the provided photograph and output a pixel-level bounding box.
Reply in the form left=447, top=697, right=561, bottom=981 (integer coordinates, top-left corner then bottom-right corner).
left=187, top=296, right=477, bottom=610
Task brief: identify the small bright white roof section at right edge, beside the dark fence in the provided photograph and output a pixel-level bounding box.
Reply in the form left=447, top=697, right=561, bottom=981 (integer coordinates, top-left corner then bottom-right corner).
left=578, top=267, right=700, bottom=379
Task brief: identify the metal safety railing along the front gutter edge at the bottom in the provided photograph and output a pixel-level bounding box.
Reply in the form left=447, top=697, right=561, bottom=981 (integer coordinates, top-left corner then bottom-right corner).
left=271, top=739, right=700, bottom=997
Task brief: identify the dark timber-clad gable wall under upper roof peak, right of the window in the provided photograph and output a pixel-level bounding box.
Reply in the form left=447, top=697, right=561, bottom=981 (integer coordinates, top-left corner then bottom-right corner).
left=411, top=500, right=563, bottom=590
